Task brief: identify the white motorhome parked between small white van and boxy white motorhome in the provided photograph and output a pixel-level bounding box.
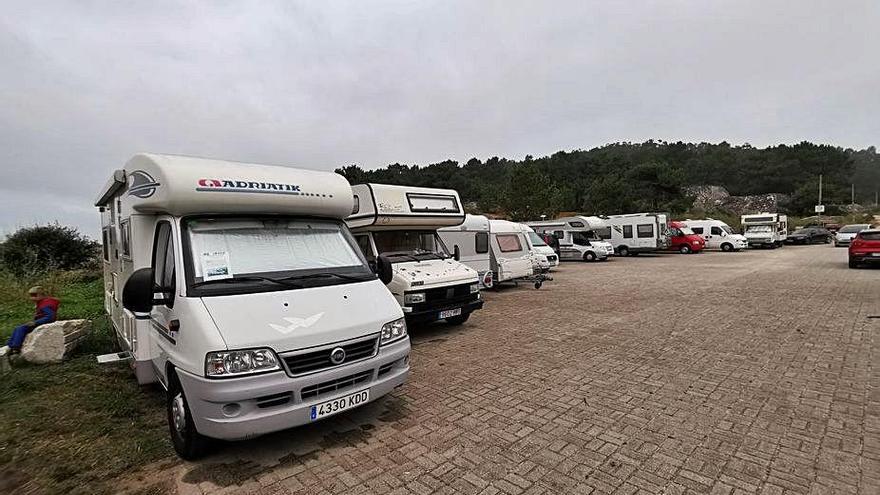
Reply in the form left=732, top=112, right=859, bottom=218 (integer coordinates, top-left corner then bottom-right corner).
left=525, top=217, right=614, bottom=261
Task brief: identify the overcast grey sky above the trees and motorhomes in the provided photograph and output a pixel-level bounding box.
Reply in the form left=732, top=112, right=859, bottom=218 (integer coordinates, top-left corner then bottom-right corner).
left=0, top=0, right=880, bottom=235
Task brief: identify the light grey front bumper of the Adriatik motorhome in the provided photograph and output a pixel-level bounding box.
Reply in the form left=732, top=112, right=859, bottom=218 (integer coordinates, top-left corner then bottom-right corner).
left=177, top=338, right=410, bottom=440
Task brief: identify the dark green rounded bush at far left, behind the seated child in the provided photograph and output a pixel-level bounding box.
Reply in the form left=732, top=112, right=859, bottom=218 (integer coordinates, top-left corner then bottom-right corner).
left=0, top=224, right=99, bottom=277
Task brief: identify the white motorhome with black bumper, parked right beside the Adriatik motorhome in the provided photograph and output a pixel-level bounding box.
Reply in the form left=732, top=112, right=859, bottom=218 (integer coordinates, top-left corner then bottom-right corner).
left=345, top=184, right=483, bottom=325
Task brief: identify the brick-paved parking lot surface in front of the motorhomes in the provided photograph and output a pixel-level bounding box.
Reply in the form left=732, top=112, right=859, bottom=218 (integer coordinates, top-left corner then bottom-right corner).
left=167, top=246, right=880, bottom=494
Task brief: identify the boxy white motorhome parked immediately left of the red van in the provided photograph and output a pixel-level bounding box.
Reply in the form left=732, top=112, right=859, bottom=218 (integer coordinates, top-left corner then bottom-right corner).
left=586, top=213, right=669, bottom=256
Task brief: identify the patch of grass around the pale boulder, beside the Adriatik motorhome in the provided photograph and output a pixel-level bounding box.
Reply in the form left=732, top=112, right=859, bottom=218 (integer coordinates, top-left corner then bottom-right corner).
left=0, top=274, right=173, bottom=493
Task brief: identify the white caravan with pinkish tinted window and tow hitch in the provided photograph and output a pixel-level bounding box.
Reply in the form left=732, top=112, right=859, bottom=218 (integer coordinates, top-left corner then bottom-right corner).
left=489, top=220, right=535, bottom=283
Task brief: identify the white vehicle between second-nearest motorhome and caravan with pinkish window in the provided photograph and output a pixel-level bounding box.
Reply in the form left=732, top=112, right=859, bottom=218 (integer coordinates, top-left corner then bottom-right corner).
left=437, top=214, right=494, bottom=289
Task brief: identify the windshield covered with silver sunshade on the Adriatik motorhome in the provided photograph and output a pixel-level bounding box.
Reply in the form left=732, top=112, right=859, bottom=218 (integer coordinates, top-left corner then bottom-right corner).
left=184, top=217, right=375, bottom=295
